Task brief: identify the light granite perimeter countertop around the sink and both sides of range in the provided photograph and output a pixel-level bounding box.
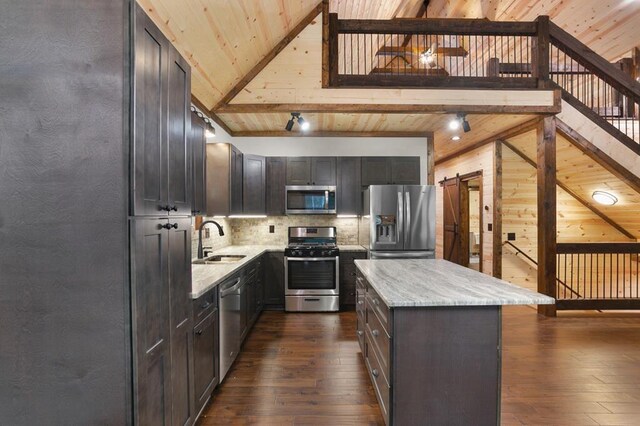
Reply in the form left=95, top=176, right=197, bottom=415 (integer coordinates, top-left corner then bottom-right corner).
left=190, top=245, right=367, bottom=299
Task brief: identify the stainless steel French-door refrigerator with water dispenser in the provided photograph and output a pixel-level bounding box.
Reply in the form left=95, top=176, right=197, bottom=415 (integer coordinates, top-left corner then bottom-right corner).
left=361, top=185, right=436, bottom=259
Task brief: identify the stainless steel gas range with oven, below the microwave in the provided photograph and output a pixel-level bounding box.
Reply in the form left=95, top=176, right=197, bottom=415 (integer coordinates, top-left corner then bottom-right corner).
left=284, top=226, right=340, bottom=312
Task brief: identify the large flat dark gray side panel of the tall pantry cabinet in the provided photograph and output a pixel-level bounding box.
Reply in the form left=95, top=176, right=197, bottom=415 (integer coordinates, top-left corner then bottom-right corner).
left=0, top=0, right=130, bottom=425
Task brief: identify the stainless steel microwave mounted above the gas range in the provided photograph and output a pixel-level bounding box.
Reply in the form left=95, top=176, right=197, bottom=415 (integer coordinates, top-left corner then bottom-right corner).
left=285, top=185, right=336, bottom=214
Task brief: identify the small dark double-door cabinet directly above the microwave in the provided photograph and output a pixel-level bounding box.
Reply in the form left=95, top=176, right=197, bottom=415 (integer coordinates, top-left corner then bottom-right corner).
left=286, top=157, right=336, bottom=185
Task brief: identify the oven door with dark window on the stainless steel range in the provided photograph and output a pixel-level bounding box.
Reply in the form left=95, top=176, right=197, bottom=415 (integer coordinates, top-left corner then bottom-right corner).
left=284, top=256, right=340, bottom=296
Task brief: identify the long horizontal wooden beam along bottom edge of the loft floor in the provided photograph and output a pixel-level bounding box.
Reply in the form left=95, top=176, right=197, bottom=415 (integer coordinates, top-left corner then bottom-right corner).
left=215, top=103, right=559, bottom=114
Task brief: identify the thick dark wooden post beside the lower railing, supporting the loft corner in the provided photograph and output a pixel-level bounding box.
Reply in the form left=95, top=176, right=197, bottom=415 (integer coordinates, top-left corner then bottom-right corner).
left=537, top=116, right=556, bottom=316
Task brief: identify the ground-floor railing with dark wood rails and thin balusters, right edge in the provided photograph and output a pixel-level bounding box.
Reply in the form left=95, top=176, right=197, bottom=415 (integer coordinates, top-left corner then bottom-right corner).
left=556, top=243, right=640, bottom=309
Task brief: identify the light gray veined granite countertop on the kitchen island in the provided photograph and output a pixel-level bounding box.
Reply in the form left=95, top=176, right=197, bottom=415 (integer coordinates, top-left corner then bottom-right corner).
left=355, top=259, right=555, bottom=308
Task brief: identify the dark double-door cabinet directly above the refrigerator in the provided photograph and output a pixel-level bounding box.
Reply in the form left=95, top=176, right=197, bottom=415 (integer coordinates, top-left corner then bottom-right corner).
left=362, top=157, right=420, bottom=186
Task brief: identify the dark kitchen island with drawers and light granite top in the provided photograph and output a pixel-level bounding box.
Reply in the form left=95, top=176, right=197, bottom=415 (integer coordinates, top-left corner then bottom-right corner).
left=355, top=259, right=555, bottom=425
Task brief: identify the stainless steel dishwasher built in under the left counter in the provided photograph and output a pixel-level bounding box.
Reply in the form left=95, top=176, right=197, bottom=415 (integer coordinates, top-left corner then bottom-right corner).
left=219, top=276, right=245, bottom=382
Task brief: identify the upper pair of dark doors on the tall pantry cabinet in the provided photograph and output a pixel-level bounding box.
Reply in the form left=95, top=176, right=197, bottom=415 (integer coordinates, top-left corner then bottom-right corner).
left=131, top=7, right=191, bottom=216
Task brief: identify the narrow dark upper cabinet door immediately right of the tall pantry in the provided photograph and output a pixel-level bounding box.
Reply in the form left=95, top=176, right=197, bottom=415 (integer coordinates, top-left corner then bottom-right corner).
left=189, top=113, right=207, bottom=215
